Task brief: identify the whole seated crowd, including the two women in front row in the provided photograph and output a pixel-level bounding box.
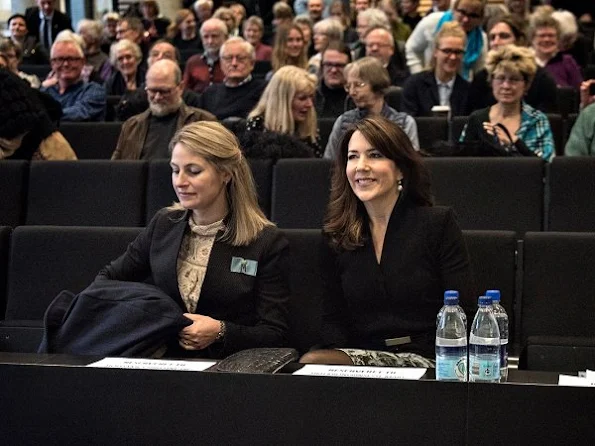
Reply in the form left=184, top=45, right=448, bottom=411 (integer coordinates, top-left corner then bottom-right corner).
left=0, top=0, right=595, bottom=367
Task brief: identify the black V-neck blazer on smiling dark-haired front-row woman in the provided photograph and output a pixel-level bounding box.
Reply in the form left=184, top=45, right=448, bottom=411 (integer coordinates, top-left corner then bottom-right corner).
left=321, top=199, right=475, bottom=357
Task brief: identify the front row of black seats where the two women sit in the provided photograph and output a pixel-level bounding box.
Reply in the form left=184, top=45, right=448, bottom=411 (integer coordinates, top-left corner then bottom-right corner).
left=0, top=226, right=595, bottom=370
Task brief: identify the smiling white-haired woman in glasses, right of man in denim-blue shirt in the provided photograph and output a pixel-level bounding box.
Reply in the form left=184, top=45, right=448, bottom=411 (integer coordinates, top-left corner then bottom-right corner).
left=105, top=39, right=145, bottom=96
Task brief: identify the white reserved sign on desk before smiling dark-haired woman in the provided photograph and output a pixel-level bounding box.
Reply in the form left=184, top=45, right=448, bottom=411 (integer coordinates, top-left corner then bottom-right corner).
left=293, top=364, right=426, bottom=380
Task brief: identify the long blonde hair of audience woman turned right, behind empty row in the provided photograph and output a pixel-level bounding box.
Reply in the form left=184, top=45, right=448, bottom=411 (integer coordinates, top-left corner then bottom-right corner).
left=248, top=65, right=317, bottom=142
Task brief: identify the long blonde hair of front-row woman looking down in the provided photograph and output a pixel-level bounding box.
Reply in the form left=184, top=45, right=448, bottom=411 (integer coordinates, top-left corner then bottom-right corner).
left=168, top=121, right=273, bottom=246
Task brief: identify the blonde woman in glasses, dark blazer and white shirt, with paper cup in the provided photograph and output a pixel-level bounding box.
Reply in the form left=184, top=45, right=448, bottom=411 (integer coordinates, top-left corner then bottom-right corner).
left=401, top=22, right=469, bottom=116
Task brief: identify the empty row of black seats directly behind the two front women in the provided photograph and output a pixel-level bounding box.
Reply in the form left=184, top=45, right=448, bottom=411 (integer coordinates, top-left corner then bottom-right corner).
left=0, top=157, right=595, bottom=234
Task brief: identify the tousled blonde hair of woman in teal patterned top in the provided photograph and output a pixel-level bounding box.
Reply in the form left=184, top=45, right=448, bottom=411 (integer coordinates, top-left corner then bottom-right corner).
left=486, top=45, right=537, bottom=88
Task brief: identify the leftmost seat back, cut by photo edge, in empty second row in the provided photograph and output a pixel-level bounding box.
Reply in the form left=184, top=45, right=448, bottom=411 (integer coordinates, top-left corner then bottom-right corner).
left=0, top=160, right=29, bottom=226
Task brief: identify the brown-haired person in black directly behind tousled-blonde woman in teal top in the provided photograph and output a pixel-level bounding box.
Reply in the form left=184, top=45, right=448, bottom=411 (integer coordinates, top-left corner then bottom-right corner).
left=469, top=15, right=558, bottom=113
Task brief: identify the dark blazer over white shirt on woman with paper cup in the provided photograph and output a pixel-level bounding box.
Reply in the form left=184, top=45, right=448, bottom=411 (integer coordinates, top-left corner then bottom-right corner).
left=401, top=71, right=469, bottom=116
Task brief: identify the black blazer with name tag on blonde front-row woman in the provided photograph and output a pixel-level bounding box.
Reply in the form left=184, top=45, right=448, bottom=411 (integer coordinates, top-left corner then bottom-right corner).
left=98, top=209, right=289, bottom=358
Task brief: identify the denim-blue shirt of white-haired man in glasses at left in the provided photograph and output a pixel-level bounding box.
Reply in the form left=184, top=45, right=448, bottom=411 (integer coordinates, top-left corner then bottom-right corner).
left=42, top=81, right=106, bottom=121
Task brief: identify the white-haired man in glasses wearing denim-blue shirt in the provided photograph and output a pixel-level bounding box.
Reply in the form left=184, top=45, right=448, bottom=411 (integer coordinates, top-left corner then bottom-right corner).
left=42, top=39, right=106, bottom=121
